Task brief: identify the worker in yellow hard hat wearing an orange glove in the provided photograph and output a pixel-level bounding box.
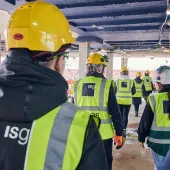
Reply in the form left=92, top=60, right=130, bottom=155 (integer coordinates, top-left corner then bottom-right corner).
left=73, top=52, right=123, bottom=170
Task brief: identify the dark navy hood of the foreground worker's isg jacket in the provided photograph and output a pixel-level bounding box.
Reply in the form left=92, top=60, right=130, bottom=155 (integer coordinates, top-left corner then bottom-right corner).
left=0, top=50, right=68, bottom=121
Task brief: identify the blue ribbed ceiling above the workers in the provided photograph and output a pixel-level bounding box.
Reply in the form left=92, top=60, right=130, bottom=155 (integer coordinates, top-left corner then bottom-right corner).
left=0, top=0, right=170, bottom=50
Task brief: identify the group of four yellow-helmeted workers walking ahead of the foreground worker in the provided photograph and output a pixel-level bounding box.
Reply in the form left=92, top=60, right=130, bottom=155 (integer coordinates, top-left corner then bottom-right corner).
left=72, top=52, right=153, bottom=169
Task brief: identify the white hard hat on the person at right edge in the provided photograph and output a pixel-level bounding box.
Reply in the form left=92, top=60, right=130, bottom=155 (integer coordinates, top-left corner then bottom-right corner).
left=156, top=66, right=170, bottom=85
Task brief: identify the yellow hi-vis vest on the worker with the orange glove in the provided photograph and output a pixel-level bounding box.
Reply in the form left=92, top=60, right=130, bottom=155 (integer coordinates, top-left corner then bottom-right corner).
left=73, top=76, right=114, bottom=140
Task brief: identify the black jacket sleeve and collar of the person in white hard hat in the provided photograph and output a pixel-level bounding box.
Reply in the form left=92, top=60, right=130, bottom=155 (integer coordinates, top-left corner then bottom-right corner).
left=138, top=88, right=170, bottom=142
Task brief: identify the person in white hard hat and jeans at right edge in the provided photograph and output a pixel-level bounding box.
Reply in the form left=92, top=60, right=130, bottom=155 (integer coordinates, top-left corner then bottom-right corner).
left=138, top=66, right=170, bottom=170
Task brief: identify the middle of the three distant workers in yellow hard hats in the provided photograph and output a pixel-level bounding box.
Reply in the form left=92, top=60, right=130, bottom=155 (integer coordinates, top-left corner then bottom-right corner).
left=132, top=72, right=144, bottom=117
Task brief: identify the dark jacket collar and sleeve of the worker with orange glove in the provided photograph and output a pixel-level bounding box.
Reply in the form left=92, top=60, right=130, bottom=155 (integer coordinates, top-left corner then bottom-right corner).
left=86, top=72, right=123, bottom=136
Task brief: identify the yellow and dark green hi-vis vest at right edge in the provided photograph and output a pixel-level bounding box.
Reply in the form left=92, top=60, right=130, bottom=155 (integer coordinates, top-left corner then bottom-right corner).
left=148, top=92, right=170, bottom=156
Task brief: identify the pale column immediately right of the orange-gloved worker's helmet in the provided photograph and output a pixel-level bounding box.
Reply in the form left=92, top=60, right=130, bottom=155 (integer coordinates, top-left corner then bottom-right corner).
left=106, top=53, right=113, bottom=80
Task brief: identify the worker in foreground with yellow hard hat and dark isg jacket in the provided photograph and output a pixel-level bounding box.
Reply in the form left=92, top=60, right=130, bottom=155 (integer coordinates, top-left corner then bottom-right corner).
left=0, top=1, right=108, bottom=170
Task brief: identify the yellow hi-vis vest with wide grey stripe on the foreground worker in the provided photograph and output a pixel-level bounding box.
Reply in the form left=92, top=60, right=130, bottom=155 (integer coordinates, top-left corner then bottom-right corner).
left=24, top=103, right=93, bottom=170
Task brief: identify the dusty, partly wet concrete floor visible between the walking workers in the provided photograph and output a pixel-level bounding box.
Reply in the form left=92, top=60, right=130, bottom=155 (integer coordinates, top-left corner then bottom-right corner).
left=113, top=102, right=153, bottom=170
